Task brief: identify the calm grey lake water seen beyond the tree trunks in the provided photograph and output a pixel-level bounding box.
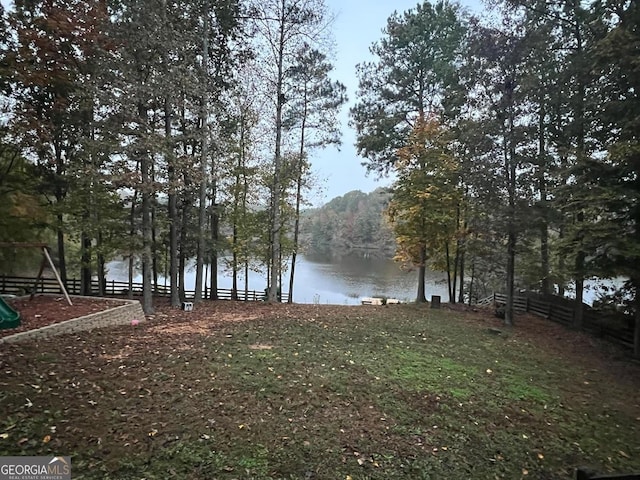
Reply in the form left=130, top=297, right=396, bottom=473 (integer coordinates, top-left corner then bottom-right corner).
left=107, top=255, right=449, bottom=305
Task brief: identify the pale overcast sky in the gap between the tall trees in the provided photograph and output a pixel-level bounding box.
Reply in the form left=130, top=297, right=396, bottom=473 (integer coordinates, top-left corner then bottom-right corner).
left=311, top=0, right=482, bottom=204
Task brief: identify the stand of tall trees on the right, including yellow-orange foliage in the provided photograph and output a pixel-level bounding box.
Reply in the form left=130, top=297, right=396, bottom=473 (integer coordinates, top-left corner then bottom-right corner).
left=351, top=0, right=640, bottom=355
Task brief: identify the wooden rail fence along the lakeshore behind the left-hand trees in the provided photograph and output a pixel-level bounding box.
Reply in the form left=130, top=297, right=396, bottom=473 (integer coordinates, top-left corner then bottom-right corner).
left=0, top=275, right=288, bottom=302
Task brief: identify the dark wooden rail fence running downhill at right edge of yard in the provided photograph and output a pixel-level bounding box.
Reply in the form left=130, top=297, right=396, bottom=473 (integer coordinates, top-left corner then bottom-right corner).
left=476, top=293, right=633, bottom=347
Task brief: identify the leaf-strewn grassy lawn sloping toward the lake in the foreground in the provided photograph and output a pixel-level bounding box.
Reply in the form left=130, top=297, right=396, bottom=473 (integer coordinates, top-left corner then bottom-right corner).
left=0, top=302, right=640, bottom=480
